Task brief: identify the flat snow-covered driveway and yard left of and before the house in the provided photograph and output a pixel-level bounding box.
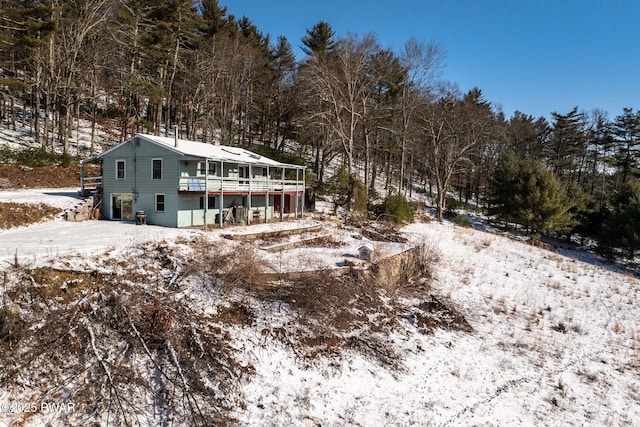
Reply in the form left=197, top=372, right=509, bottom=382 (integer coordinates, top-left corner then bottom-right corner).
left=0, top=188, right=408, bottom=271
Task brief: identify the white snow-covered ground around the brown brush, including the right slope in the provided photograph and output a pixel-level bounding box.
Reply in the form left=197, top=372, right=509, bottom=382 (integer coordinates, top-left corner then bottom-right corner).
left=0, top=190, right=640, bottom=426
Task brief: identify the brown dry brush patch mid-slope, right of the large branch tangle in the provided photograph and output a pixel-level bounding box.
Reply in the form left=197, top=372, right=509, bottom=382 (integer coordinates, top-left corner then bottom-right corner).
left=190, top=237, right=464, bottom=368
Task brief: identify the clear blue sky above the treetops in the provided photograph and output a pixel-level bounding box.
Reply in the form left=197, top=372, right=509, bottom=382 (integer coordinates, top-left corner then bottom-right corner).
left=219, top=0, right=640, bottom=118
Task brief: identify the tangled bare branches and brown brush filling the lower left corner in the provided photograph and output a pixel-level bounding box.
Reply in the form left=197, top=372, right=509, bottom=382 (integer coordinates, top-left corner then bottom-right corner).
left=0, top=268, right=252, bottom=426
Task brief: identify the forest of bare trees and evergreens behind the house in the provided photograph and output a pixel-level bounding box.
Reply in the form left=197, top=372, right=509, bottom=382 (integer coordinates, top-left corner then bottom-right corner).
left=0, top=0, right=640, bottom=259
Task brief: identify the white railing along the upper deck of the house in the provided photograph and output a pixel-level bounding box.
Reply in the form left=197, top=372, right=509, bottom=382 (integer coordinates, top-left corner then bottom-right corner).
left=178, top=176, right=304, bottom=192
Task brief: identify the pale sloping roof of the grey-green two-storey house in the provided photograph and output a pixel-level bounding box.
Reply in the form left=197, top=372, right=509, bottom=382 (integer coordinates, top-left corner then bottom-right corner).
left=85, top=133, right=304, bottom=169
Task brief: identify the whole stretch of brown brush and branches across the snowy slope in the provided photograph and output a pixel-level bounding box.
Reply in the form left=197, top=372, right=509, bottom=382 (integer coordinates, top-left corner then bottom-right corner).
left=0, top=232, right=471, bottom=425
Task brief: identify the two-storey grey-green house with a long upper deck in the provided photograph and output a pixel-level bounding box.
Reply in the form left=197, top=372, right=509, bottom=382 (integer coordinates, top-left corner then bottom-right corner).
left=81, top=134, right=305, bottom=227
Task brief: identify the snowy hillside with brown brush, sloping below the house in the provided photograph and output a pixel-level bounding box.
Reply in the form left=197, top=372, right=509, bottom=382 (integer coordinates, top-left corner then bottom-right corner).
left=0, top=185, right=640, bottom=426
